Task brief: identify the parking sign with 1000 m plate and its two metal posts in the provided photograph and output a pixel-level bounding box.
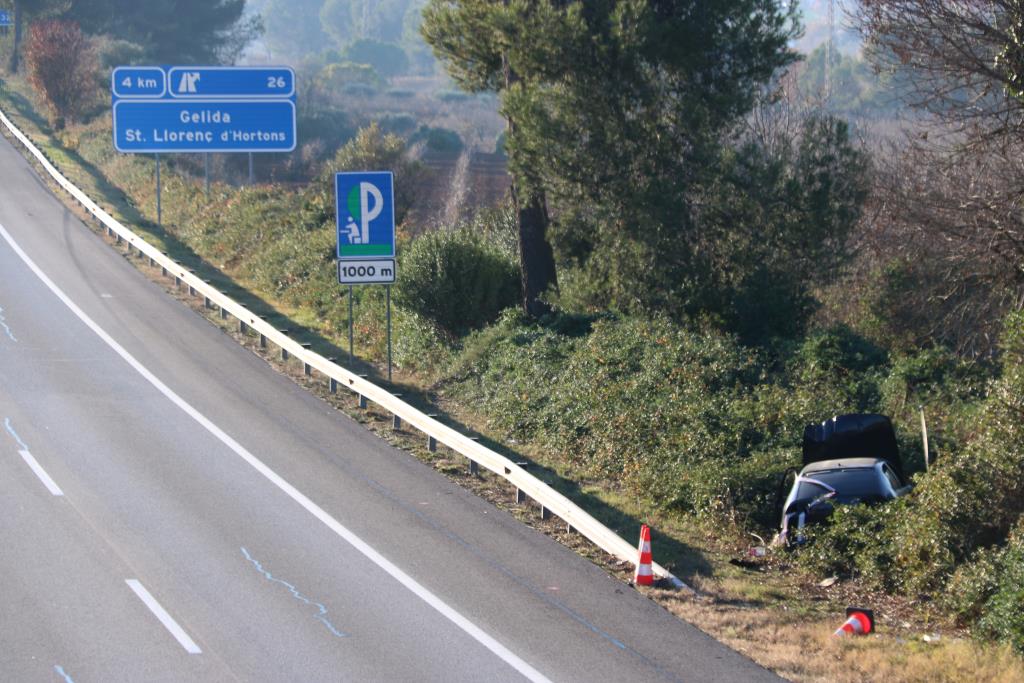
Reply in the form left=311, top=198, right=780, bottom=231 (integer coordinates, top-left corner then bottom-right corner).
left=334, top=171, right=396, bottom=374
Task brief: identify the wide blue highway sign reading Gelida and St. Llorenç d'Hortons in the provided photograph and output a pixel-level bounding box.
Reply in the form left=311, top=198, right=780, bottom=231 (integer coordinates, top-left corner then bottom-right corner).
left=111, top=67, right=296, bottom=154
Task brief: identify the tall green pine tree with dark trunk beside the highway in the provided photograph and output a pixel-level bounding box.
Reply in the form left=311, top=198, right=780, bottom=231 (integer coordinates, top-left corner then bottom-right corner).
left=423, top=0, right=799, bottom=319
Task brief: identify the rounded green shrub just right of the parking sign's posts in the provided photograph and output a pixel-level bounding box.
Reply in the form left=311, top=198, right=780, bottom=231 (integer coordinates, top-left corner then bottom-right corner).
left=395, top=228, right=519, bottom=337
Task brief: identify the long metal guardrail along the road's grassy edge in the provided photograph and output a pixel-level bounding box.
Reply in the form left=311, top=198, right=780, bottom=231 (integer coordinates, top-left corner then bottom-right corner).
left=0, top=104, right=689, bottom=589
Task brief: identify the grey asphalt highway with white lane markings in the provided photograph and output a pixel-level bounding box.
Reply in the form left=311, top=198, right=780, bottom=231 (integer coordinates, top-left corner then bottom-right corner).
left=0, top=129, right=777, bottom=682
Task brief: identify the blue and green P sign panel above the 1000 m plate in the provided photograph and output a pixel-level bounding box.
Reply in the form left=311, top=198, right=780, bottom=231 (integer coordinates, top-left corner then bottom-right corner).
left=335, top=171, right=394, bottom=260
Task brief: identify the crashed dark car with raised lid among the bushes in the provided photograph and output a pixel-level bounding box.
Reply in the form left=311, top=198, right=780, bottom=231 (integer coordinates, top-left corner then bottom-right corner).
left=776, top=414, right=911, bottom=545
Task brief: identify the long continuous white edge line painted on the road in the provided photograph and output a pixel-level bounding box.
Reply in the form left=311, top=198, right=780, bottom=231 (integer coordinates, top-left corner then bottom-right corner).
left=0, top=225, right=550, bottom=683
